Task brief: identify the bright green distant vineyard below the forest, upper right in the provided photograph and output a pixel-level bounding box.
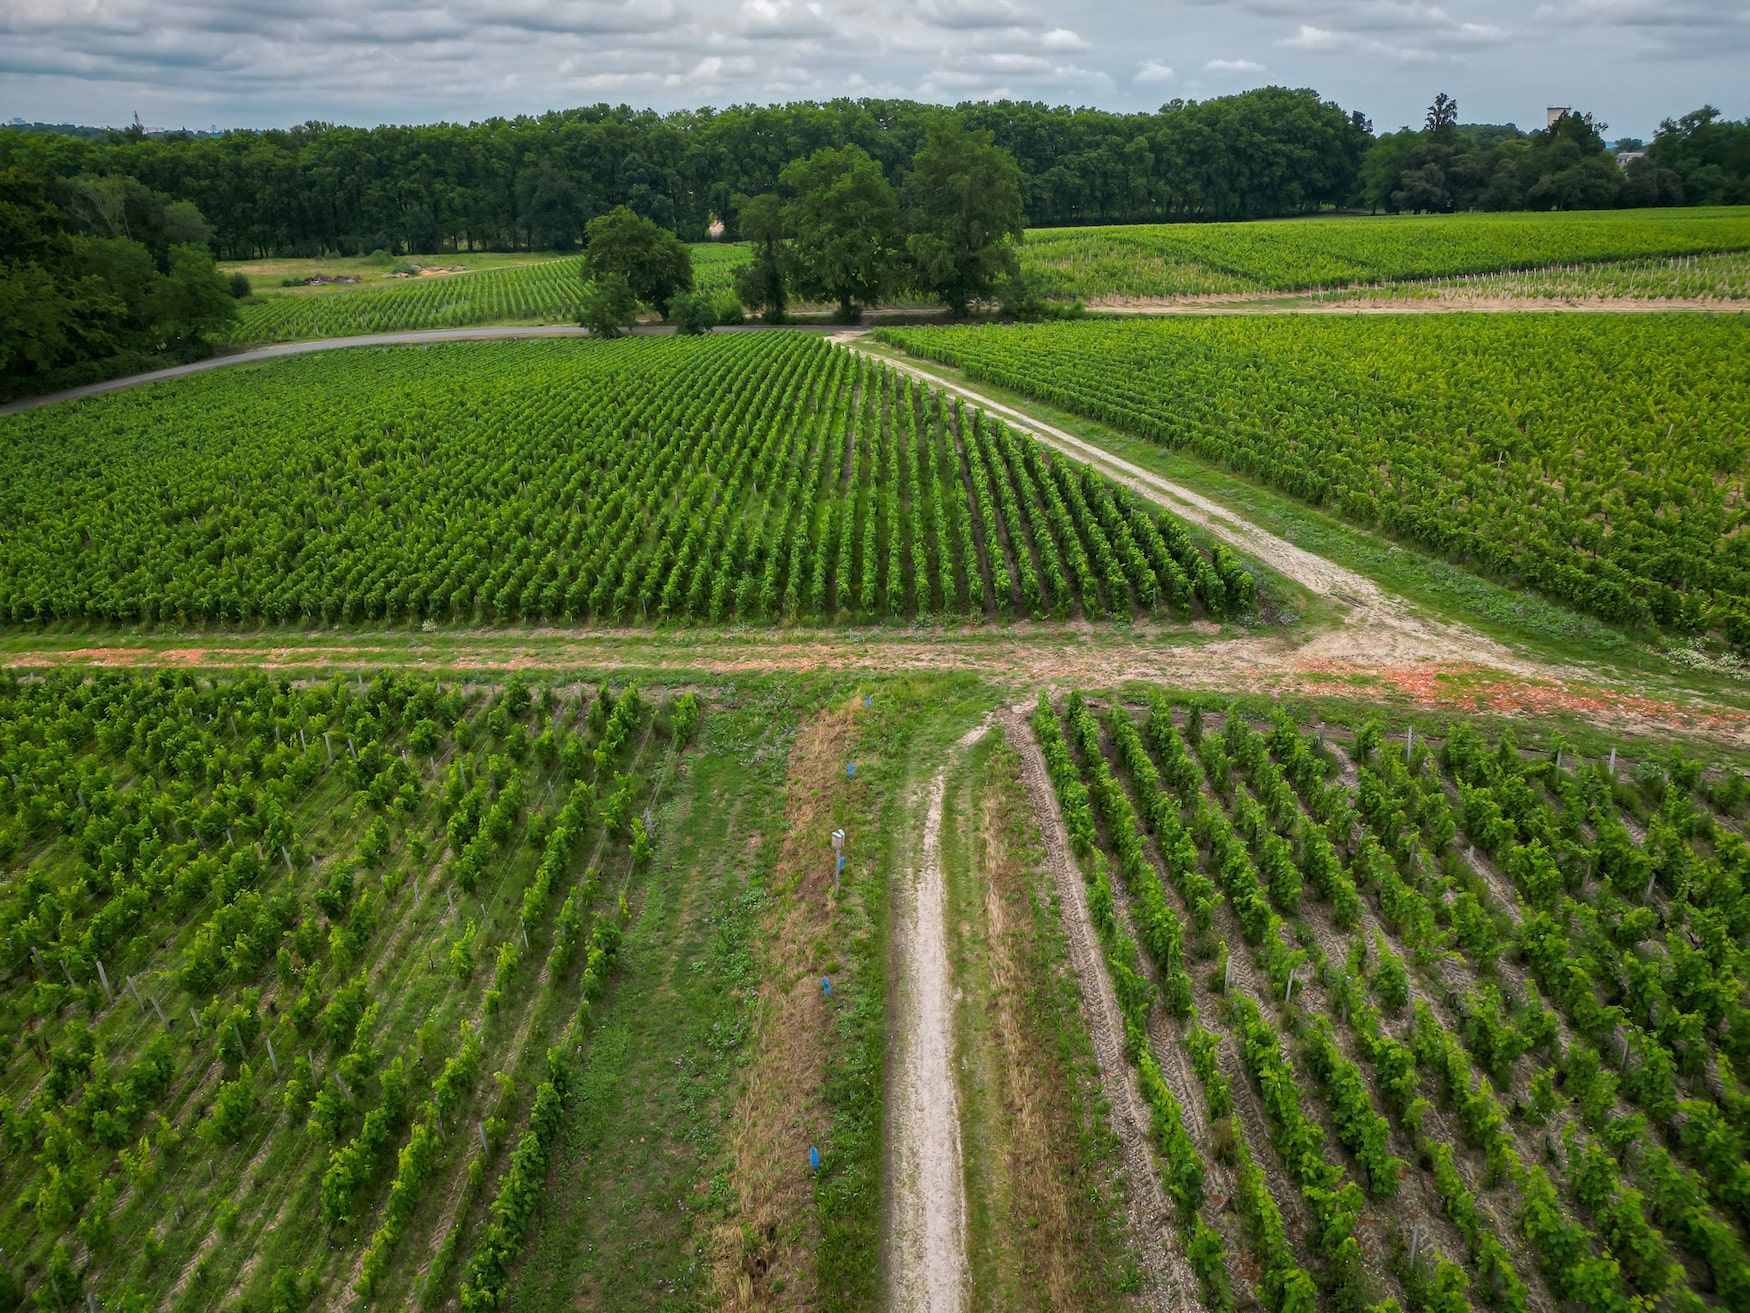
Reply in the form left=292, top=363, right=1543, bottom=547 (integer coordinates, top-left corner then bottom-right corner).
left=1022, top=207, right=1750, bottom=301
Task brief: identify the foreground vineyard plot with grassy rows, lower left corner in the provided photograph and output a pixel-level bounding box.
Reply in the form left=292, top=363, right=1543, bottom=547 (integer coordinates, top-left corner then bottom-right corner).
left=0, top=674, right=700, bottom=1311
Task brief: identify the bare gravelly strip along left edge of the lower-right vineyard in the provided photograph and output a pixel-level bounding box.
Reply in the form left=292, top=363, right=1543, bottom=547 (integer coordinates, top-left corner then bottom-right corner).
left=998, top=709, right=1199, bottom=1313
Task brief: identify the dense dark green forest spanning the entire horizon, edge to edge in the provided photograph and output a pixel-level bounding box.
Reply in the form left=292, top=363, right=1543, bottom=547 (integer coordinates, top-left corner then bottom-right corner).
left=0, top=88, right=1750, bottom=257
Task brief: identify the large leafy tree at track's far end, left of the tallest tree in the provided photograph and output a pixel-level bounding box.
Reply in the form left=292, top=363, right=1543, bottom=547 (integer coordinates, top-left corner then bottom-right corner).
left=779, top=145, right=900, bottom=320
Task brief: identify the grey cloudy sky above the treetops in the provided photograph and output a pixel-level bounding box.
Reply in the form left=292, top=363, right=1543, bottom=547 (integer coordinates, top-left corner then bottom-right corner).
left=0, top=0, right=1750, bottom=137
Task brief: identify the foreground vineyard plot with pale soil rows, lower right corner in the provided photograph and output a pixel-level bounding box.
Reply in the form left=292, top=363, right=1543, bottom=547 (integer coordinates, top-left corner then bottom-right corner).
left=1033, top=693, right=1750, bottom=1313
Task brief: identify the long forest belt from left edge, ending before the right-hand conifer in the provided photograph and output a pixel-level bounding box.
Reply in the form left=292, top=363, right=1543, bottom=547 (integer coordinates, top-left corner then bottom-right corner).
left=0, top=88, right=1372, bottom=259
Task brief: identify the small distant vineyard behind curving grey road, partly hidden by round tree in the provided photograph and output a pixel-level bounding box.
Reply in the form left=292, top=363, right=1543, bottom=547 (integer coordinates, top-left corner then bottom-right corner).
left=231, top=243, right=747, bottom=343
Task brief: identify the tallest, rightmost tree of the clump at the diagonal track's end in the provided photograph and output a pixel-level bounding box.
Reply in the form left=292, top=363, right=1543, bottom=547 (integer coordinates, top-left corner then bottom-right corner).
left=900, top=119, right=1022, bottom=315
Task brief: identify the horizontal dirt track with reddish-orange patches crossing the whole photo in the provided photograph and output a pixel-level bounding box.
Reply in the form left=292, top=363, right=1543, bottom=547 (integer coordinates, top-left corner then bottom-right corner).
left=10, top=621, right=1750, bottom=748
